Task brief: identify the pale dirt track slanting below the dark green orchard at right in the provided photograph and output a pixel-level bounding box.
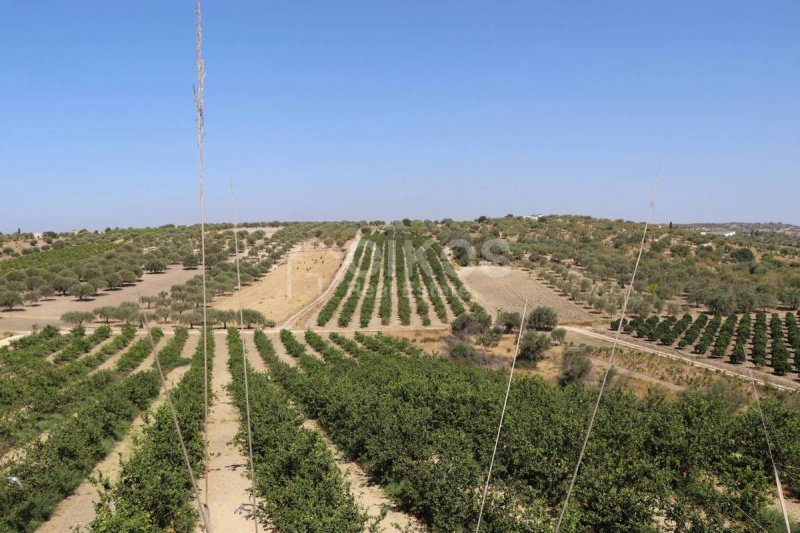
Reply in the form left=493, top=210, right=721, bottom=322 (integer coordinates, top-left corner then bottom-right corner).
left=564, top=326, right=800, bottom=391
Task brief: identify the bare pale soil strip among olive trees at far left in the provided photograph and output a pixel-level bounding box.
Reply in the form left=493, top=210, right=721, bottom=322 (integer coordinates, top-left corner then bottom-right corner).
left=0, top=266, right=199, bottom=331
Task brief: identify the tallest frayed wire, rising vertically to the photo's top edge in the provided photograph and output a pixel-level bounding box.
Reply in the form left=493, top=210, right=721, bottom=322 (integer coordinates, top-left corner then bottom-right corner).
left=194, top=0, right=208, bottom=512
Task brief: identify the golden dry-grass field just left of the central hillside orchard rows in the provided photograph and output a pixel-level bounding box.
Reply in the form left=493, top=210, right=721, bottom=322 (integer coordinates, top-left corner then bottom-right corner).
left=214, top=243, right=344, bottom=324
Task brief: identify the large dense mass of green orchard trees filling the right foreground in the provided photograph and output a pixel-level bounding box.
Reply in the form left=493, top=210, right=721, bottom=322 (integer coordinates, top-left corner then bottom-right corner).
left=268, top=332, right=800, bottom=532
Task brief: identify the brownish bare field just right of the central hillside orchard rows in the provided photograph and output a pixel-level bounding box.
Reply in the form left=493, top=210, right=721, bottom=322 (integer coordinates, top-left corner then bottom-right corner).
left=457, top=266, right=598, bottom=324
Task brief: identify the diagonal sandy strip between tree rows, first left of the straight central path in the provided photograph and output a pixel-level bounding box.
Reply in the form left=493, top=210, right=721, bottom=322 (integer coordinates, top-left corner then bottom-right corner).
left=37, top=366, right=189, bottom=533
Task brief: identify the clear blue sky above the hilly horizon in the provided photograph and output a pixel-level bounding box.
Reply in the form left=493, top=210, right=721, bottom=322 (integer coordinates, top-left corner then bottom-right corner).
left=0, top=0, right=800, bottom=231
